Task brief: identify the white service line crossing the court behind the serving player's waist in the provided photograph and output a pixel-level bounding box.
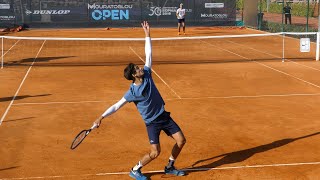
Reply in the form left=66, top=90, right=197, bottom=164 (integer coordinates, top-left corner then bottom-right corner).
left=8, top=93, right=320, bottom=106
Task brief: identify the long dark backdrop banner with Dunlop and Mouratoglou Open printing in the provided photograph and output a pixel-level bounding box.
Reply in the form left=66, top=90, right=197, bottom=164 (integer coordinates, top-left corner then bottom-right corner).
left=0, top=0, right=236, bottom=28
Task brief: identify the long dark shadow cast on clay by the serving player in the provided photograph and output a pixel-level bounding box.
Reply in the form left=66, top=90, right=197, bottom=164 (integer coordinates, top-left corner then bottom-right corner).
left=184, top=132, right=320, bottom=173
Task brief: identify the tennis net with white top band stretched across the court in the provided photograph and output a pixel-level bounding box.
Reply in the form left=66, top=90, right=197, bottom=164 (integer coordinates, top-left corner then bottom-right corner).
left=0, top=32, right=319, bottom=67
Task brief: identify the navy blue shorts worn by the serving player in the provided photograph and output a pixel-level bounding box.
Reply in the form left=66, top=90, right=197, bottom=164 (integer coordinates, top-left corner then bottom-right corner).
left=147, top=111, right=181, bottom=144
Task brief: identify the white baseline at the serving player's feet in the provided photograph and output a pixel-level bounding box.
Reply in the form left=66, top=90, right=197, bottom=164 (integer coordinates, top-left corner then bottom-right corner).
left=0, top=162, right=320, bottom=180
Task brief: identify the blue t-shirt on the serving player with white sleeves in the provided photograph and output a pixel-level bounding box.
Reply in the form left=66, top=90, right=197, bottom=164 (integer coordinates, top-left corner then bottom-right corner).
left=124, top=66, right=165, bottom=124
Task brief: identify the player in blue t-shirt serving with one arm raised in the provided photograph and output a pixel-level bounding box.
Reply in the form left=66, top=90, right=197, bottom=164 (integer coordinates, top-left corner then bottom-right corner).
left=94, top=21, right=186, bottom=180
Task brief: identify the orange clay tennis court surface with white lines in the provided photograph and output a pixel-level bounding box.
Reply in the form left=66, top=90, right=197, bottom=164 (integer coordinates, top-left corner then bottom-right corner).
left=0, top=27, right=320, bottom=180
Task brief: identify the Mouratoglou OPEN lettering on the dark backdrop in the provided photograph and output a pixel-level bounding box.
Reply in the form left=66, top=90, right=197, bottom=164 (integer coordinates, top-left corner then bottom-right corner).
left=88, top=4, right=133, bottom=21
